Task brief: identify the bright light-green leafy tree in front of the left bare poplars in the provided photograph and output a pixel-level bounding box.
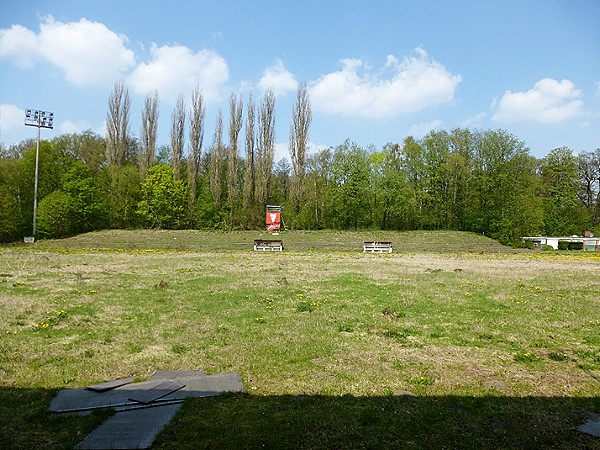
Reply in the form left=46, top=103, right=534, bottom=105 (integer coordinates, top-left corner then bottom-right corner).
left=138, top=164, right=188, bottom=229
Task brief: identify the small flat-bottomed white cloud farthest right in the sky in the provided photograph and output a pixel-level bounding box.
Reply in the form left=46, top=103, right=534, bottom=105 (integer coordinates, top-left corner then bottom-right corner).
left=492, top=78, right=583, bottom=123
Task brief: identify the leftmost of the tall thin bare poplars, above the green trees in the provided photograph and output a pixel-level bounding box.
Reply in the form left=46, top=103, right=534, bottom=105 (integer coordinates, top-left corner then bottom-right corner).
left=106, top=80, right=131, bottom=166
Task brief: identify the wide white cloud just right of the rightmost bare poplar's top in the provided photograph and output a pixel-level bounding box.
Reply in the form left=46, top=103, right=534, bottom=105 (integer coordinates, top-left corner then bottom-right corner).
left=310, top=48, right=461, bottom=118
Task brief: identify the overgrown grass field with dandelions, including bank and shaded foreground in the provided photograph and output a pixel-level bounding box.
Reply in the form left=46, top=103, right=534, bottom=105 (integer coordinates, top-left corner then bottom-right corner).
left=0, top=231, right=600, bottom=449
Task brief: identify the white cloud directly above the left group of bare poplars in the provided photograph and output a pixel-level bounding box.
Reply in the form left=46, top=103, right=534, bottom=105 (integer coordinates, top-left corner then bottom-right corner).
left=128, top=44, right=229, bottom=103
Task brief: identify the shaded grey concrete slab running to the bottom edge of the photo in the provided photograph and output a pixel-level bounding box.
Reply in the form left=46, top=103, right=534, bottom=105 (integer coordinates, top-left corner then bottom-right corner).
left=75, top=404, right=181, bottom=450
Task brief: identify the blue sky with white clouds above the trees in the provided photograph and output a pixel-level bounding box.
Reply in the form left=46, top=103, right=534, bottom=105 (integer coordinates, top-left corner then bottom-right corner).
left=0, top=0, right=600, bottom=160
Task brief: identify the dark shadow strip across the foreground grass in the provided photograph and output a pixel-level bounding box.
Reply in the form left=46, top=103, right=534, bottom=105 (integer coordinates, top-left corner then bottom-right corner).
left=0, top=388, right=600, bottom=450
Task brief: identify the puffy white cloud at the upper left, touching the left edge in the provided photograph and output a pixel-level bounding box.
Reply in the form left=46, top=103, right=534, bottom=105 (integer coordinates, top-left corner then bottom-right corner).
left=0, top=16, right=135, bottom=86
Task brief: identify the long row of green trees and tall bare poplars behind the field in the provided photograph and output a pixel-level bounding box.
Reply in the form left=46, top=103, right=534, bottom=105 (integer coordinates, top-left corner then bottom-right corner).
left=0, top=82, right=600, bottom=244
